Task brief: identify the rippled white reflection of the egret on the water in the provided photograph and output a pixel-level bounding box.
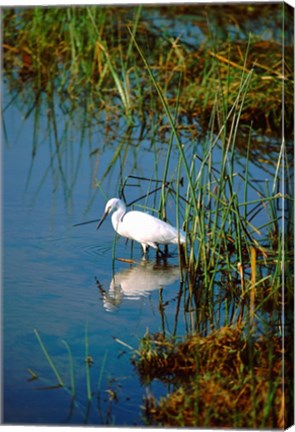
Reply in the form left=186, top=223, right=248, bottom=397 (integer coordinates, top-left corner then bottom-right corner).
left=96, top=261, right=180, bottom=312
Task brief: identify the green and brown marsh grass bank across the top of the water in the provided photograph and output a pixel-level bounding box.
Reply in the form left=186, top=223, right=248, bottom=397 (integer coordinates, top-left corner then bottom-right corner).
left=3, top=5, right=293, bottom=135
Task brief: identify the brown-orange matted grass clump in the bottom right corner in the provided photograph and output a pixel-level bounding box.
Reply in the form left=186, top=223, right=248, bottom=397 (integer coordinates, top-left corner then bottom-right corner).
left=132, top=326, right=292, bottom=428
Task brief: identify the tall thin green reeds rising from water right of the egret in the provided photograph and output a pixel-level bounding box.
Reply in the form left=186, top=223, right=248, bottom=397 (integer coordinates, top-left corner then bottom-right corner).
left=131, top=32, right=294, bottom=338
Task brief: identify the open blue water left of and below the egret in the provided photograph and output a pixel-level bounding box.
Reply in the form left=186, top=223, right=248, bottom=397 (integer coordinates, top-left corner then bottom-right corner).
left=3, top=93, right=192, bottom=425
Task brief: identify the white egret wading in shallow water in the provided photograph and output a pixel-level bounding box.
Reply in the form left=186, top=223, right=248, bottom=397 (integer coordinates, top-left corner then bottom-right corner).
left=97, top=198, right=185, bottom=257
